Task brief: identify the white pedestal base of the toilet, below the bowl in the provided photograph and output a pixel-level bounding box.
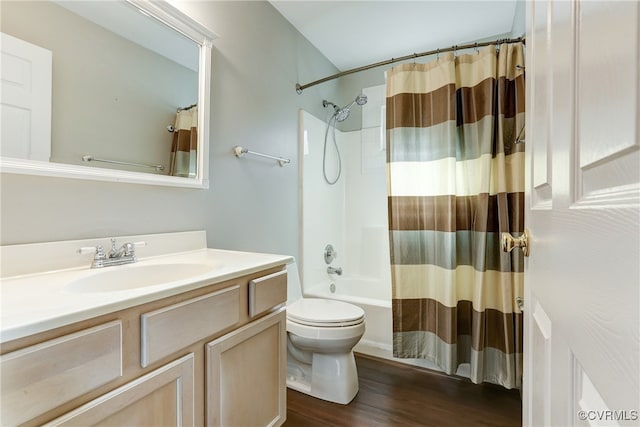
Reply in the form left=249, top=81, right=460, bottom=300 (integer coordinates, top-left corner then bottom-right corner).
left=287, top=351, right=359, bottom=405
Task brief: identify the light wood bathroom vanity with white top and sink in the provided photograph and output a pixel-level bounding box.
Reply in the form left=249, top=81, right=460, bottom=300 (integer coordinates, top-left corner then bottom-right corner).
left=0, top=231, right=292, bottom=426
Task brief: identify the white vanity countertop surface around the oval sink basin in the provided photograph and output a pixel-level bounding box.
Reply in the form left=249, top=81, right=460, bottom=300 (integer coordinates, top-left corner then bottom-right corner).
left=0, top=248, right=293, bottom=343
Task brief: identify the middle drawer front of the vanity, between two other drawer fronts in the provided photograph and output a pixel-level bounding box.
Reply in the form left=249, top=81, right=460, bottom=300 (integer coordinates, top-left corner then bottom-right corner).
left=140, top=285, right=240, bottom=368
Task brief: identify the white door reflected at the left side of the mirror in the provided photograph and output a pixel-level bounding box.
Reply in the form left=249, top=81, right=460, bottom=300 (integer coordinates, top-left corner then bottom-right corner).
left=0, top=33, right=52, bottom=162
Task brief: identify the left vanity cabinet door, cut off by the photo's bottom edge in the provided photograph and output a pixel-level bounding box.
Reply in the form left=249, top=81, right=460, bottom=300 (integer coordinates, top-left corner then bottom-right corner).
left=45, top=353, right=194, bottom=427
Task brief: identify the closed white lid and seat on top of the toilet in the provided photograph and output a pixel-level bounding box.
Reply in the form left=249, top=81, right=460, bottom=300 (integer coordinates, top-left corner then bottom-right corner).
left=287, top=298, right=364, bottom=327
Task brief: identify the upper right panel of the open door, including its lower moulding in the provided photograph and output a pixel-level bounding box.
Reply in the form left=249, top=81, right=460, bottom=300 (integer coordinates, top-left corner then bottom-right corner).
left=575, top=1, right=640, bottom=207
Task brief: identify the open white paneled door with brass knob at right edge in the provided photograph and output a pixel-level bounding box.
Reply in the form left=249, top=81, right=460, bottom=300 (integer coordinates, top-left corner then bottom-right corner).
left=523, top=0, right=640, bottom=426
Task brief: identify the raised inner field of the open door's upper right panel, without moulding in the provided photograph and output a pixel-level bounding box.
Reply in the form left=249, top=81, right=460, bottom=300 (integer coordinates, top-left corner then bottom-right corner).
left=576, top=1, right=638, bottom=170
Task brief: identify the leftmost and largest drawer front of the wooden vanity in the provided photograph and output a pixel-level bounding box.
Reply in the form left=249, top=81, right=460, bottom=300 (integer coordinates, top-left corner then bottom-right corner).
left=0, top=321, right=122, bottom=426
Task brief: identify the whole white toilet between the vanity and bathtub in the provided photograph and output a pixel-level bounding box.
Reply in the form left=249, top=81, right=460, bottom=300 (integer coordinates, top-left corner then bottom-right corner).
left=287, top=262, right=365, bottom=405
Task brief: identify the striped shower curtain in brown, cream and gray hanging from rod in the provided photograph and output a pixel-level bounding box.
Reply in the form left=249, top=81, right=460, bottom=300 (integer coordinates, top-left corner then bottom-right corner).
left=386, top=43, right=525, bottom=388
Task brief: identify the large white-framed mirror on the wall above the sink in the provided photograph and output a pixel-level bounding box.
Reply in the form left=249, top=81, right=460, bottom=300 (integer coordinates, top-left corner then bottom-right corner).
left=0, top=0, right=215, bottom=188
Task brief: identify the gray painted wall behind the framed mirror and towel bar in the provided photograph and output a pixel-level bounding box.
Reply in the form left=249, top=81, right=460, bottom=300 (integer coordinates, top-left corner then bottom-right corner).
left=0, top=1, right=338, bottom=264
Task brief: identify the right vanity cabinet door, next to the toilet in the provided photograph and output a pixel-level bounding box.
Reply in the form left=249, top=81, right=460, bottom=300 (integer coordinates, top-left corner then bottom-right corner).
left=206, top=308, right=287, bottom=427
